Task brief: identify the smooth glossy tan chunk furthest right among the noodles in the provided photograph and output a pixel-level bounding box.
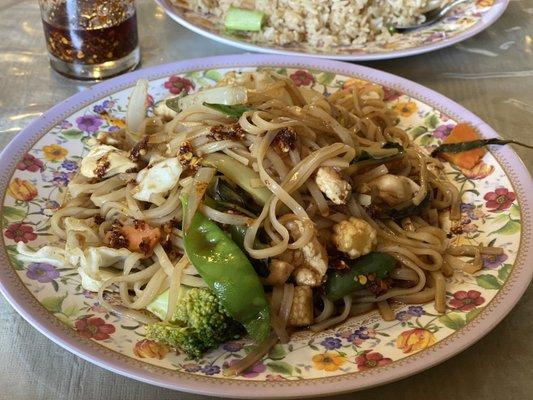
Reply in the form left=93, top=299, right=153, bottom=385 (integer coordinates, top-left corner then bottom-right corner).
left=367, top=174, right=420, bottom=207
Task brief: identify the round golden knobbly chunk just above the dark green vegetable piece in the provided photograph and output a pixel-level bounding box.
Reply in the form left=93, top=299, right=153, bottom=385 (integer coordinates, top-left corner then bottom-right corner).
left=331, top=217, right=378, bottom=259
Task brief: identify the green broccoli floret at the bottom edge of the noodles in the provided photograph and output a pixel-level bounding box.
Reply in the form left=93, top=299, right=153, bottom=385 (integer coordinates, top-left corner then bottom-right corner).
left=142, top=288, right=243, bottom=358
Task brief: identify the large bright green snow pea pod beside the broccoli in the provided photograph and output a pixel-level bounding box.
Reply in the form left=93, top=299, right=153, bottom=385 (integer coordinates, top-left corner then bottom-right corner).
left=184, top=207, right=270, bottom=342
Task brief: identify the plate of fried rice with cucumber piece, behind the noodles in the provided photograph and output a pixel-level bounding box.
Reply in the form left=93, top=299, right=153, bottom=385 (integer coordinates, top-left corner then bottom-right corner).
left=156, top=0, right=509, bottom=61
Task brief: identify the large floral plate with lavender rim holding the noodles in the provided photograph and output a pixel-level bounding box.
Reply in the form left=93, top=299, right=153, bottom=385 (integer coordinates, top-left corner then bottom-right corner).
left=0, top=55, right=533, bottom=398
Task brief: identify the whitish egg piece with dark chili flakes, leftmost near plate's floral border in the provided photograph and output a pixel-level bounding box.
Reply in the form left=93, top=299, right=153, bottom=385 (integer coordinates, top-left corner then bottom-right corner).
left=80, top=144, right=137, bottom=179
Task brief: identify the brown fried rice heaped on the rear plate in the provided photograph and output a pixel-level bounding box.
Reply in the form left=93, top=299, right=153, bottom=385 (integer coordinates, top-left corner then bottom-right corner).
left=185, top=0, right=446, bottom=48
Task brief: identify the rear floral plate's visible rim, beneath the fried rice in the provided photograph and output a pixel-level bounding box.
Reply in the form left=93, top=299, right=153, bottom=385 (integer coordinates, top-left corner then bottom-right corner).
left=155, top=0, right=509, bottom=61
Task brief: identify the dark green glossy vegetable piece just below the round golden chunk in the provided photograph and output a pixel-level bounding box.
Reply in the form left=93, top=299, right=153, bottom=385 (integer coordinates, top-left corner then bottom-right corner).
left=325, top=252, right=396, bottom=301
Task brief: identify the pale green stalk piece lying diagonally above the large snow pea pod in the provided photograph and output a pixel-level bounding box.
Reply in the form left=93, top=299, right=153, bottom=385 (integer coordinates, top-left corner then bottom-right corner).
left=203, top=153, right=272, bottom=206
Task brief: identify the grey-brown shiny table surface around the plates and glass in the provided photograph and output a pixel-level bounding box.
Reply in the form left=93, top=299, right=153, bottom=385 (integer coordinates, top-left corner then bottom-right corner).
left=0, top=0, right=533, bottom=400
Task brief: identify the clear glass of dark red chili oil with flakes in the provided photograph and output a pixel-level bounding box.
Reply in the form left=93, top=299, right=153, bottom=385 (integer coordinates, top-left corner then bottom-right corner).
left=39, top=0, right=140, bottom=79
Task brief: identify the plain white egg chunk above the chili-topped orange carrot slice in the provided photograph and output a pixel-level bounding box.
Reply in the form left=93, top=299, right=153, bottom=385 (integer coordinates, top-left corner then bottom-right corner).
left=133, top=158, right=183, bottom=205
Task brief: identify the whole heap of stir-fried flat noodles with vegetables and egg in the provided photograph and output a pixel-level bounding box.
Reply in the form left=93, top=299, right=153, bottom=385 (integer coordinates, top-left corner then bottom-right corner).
left=18, top=70, right=501, bottom=374
